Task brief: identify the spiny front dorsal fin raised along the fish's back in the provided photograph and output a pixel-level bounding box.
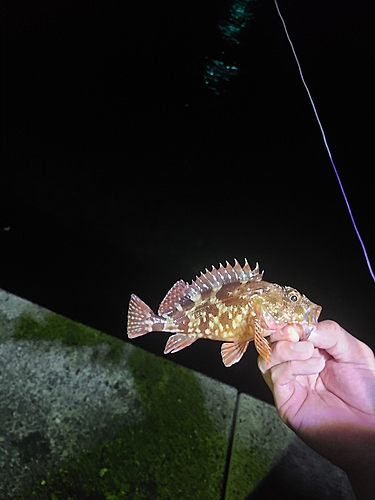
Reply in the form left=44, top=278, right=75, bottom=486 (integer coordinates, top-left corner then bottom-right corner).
left=189, top=259, right=263, bottom=298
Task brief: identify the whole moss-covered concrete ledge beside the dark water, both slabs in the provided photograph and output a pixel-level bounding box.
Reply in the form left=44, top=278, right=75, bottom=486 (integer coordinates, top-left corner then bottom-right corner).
left=0, top=290, right=353, bottom=500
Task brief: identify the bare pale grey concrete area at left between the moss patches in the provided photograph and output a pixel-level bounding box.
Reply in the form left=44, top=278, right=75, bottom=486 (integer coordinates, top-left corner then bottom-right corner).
left=0, top=340, right=142, bottom=495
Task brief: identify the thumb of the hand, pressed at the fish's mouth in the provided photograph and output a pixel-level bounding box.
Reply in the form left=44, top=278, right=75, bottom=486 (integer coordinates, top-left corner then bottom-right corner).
left=309, top=320, right=375, bottom=367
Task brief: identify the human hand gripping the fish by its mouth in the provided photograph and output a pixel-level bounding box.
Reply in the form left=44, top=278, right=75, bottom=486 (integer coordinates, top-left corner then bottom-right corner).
left=258, top=321, right=375, bottom=498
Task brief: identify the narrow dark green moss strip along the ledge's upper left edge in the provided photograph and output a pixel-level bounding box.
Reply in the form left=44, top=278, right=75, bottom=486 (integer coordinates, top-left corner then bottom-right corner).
left=15, top=312, right=124, bottom=362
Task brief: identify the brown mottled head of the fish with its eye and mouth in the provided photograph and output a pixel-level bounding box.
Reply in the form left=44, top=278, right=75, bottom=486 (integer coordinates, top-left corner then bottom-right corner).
left=259, top=284, right=322, bottom=340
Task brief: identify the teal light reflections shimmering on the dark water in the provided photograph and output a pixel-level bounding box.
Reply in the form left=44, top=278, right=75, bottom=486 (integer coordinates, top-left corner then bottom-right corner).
left=204, top=0, right=256, bottom=95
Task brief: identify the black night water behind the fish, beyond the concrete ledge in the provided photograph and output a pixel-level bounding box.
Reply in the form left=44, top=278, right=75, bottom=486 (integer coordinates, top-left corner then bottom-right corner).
left=0, top=0, right=375, bottom=400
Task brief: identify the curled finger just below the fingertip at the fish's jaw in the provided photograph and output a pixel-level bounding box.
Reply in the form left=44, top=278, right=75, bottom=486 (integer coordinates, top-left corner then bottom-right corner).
left=258, top=340, right=314, bottom=373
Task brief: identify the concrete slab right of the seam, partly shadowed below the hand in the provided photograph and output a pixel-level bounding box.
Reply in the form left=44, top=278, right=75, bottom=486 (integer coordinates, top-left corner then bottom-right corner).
left=225, top=394, right=354, bottom=500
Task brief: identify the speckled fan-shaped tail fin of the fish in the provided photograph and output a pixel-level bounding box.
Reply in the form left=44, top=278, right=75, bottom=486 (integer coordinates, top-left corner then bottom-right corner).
left=127, top=294, right=165, bottom=339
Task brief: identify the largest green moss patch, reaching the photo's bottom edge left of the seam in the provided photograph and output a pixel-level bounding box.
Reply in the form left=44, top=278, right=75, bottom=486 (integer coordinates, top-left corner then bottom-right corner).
left=17, top=349, right=227, bottom=500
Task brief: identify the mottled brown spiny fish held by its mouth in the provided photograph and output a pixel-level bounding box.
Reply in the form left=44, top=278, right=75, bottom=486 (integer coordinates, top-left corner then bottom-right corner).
left=127, top=259, right=322, bottom=367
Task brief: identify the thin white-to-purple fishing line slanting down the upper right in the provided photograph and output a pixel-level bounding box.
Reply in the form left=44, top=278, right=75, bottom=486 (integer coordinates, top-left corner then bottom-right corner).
left=274, top=0, right=375, bottom=281
